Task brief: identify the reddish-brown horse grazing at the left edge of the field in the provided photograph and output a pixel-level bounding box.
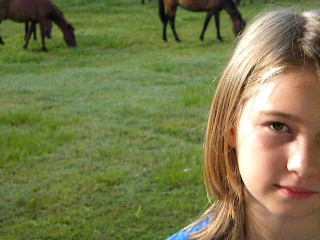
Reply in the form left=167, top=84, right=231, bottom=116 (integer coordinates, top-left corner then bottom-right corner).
left=0, top=0, right=77, bottom=51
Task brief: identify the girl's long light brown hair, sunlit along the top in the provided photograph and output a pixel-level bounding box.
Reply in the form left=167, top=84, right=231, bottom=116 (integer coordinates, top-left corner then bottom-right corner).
left=191, top=9, right=320, bottom=240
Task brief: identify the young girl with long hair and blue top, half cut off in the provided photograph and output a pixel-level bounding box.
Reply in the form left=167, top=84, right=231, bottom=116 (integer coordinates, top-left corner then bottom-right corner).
left=169, top=10, right=320, bottom=240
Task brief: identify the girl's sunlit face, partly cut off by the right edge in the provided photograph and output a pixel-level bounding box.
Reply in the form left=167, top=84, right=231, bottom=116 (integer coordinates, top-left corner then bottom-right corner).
left=230, top=67, right=320, bottom=221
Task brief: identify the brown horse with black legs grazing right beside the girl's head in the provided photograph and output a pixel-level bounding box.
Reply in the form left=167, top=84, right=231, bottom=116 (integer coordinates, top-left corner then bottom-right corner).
left=158, top=0, right=245, bottom=42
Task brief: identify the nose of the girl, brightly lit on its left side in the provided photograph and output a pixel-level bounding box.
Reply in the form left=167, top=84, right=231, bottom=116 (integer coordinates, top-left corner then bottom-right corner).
left=287, top=141, right=320, bottom=177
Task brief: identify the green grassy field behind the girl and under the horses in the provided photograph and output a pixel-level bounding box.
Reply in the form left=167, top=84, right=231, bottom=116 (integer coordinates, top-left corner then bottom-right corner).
left=0, top=0, right=320, bottom=240
